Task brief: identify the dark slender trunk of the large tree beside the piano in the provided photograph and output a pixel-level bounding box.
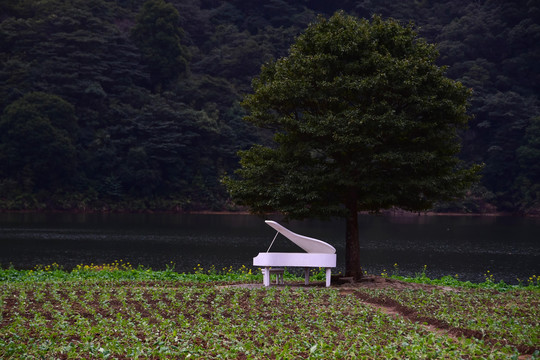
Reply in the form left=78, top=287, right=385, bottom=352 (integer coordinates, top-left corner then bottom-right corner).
left=345, top=193, right=362, bottom=280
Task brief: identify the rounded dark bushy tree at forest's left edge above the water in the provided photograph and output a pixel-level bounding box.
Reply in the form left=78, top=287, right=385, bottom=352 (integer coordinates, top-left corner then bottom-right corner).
left=0, top=93, right=78, bottom=196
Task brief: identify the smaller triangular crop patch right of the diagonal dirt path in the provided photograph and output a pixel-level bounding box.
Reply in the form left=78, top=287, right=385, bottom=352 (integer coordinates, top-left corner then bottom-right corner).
left=356, top=287, right=540, bottom=354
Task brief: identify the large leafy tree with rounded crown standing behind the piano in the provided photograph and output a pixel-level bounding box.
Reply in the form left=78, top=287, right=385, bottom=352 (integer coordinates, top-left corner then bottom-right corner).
left=225, top=12, right=479, bottom=279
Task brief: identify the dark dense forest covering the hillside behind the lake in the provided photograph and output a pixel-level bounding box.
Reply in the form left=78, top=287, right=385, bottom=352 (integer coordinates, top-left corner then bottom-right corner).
left=0, top=0, right=540, bottom=214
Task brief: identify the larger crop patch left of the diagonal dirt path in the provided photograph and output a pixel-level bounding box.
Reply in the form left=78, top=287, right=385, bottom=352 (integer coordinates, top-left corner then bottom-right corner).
left=0, top=280, right=532, bottom=359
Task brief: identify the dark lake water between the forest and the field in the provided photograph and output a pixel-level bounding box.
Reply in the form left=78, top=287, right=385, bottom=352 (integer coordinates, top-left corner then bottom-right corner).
left=0, top=213, right=540, bottom=283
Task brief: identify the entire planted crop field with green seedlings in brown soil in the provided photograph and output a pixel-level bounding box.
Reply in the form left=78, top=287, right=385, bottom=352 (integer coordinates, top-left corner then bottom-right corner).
left=0, top=266, right=540, bottom=359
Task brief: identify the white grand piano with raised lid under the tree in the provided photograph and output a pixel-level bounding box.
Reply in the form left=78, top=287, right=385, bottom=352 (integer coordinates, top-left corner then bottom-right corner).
left=253, top=220, right=337, bottom=287
